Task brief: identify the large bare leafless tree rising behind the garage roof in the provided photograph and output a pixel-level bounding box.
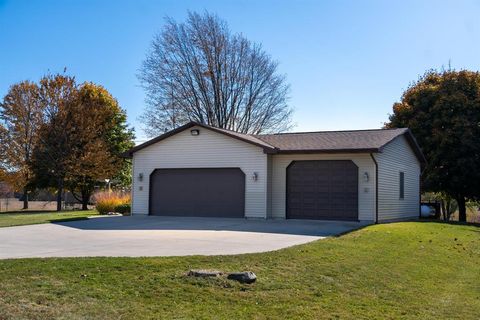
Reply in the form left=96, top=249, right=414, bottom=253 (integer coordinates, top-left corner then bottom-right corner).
left=138, top=13, right=291, bottom=136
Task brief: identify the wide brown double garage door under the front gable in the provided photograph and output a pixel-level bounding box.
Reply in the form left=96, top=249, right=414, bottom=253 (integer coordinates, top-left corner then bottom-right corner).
left=150, top=168, right=245, bottom=218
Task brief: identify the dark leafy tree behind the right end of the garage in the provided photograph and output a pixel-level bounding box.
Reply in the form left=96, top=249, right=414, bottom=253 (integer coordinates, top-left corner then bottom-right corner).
left=386, top=70, right=480, bottom=221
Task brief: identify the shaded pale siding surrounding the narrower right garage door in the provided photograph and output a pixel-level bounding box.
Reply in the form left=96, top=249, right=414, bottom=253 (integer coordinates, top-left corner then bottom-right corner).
left=271, top=154, right=375, bottom=222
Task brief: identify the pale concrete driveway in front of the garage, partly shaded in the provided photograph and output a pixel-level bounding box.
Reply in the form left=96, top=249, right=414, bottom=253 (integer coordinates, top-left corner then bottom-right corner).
left=0, top=216, right=368, bottom=259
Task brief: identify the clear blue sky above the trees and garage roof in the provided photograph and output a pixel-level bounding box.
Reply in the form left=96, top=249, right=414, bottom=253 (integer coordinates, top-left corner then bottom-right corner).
left=0, top=0, right=480, bottom=140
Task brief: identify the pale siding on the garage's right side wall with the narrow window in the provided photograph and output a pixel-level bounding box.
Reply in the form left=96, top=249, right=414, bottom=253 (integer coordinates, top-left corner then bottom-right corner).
left=375, top=136, right=421, bottom=221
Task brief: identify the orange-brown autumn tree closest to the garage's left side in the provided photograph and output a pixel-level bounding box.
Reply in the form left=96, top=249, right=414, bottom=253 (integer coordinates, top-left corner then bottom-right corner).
left=67, top=83, right=134, bottom=210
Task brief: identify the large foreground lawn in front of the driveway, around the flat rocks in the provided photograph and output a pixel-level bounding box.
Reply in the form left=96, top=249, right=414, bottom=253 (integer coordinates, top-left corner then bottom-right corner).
left=0, top=222, right=480, bottom=319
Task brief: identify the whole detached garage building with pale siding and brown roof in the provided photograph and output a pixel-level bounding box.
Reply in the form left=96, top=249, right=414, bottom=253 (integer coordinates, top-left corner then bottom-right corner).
left=127, top=122, right=425, bottom=222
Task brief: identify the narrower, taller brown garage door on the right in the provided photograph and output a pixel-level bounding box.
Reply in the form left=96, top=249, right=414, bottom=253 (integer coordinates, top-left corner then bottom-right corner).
left=287, top=160, right=358, bottom=220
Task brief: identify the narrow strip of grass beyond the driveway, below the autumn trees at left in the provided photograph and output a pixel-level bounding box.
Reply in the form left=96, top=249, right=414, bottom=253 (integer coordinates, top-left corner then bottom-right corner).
left=0, top=210, right=98, bottom=228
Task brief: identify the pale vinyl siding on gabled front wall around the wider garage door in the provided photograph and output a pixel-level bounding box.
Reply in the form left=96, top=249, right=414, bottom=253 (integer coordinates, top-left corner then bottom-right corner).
left=132, top=127, right=267, bottom=218
